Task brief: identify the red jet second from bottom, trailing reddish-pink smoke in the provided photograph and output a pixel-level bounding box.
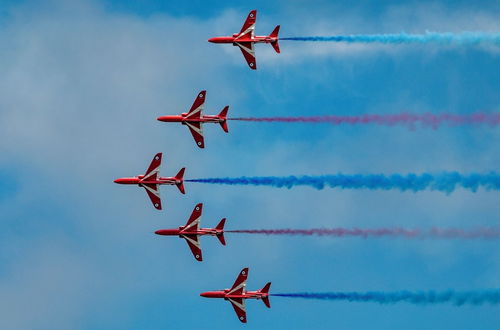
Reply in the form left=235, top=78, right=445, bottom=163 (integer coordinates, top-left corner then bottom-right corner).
left=155, top=203, right=226, bottom=261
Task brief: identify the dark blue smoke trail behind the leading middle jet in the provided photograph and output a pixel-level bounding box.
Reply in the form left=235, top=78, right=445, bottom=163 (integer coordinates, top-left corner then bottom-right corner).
left=185, top=172, right=500, bottom=193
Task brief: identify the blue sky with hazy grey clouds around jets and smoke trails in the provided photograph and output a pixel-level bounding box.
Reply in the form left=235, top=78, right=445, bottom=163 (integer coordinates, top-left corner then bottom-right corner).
left=0, top=0, right=500, bottom=329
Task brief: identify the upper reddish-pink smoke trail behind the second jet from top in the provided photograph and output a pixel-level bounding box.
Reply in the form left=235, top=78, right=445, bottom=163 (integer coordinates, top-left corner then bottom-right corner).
left=229, top=113, right=500, bottom=128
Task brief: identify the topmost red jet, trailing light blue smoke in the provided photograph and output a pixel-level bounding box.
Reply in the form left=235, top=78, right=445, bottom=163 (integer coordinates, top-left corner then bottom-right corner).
left=208, top=10, right=280, bottom=70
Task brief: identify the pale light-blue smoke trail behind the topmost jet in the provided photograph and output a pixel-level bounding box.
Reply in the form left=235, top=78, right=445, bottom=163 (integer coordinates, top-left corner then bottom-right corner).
left=280, top=32, right=500, bottom=44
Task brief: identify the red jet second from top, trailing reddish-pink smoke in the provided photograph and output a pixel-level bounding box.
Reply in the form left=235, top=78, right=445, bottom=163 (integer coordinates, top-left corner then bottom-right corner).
left=157, top=91, right=229, bottom=148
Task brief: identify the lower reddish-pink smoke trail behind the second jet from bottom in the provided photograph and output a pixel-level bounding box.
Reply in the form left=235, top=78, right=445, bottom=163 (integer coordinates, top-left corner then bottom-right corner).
left=226, top=228, right=500, bottom=239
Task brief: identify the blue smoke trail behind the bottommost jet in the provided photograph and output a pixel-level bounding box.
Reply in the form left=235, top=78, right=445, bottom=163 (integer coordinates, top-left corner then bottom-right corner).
left=270, top=290, right=500, bottom=306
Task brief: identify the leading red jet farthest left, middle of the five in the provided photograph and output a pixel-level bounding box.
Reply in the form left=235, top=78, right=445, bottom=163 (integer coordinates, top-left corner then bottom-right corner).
left=114, top=152, right=186, bottom=210
